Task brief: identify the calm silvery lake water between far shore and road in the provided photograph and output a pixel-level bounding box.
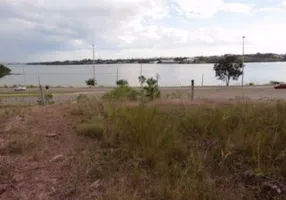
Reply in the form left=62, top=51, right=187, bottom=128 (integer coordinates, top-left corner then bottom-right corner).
left=0, top=62, right=286, bottom=87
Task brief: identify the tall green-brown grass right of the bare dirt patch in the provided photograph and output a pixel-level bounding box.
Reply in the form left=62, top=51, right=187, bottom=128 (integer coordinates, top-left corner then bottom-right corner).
left=74, top=103, right=286, bottom=199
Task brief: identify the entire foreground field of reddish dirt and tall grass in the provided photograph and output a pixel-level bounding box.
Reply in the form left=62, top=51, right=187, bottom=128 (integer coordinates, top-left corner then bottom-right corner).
left=0, top=98, right=286, bottom=200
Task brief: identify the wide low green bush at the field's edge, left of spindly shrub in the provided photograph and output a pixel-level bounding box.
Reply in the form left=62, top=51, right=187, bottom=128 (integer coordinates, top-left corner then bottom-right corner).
left=103, top=86, right=138, bottom=101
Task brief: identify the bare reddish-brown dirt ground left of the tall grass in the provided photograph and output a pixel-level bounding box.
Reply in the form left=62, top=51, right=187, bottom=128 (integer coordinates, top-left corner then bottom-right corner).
left=0, top=105, right=87, bottom=200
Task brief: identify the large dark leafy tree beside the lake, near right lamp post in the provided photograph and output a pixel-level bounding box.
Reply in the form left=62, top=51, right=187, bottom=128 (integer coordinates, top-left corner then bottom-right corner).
left=214, top=55, right=243, bottom=86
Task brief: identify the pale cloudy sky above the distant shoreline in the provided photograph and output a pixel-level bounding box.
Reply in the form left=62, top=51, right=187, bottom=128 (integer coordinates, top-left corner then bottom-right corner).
left=0, top=0, right=286, bottom=62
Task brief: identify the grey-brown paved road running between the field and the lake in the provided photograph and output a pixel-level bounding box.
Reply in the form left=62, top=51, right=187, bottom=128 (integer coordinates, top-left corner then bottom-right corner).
left=0, top=86, right=286, bottom=104
